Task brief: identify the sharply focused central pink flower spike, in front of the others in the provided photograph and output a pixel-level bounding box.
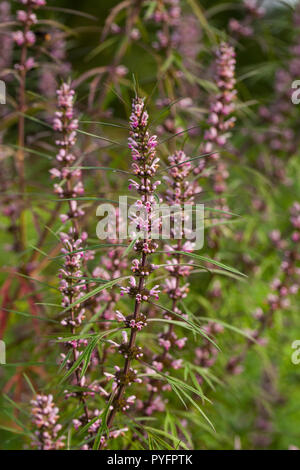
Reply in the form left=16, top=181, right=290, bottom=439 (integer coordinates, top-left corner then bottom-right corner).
left=101, top=97, right=160, bottom=446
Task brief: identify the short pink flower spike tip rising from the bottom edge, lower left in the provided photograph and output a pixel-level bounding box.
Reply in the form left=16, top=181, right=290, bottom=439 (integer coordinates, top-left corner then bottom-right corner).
left=31, top=395, right=65, bottom=450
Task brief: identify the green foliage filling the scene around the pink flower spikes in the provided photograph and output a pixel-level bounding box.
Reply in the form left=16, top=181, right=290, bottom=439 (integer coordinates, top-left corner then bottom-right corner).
left=0, top=0, right=300, bottom=450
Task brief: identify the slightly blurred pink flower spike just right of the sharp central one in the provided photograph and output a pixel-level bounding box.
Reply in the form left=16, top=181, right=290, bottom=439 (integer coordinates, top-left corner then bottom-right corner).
left=138, top=151, right=202, bottom=415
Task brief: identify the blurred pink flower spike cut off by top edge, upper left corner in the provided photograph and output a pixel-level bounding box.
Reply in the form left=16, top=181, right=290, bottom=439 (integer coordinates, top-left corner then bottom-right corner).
left=13, top=0, right=46, bottom=72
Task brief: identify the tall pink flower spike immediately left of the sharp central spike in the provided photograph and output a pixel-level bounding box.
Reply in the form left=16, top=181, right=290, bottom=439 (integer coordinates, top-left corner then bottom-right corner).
left=50, top=83, right=89, bottom=428
